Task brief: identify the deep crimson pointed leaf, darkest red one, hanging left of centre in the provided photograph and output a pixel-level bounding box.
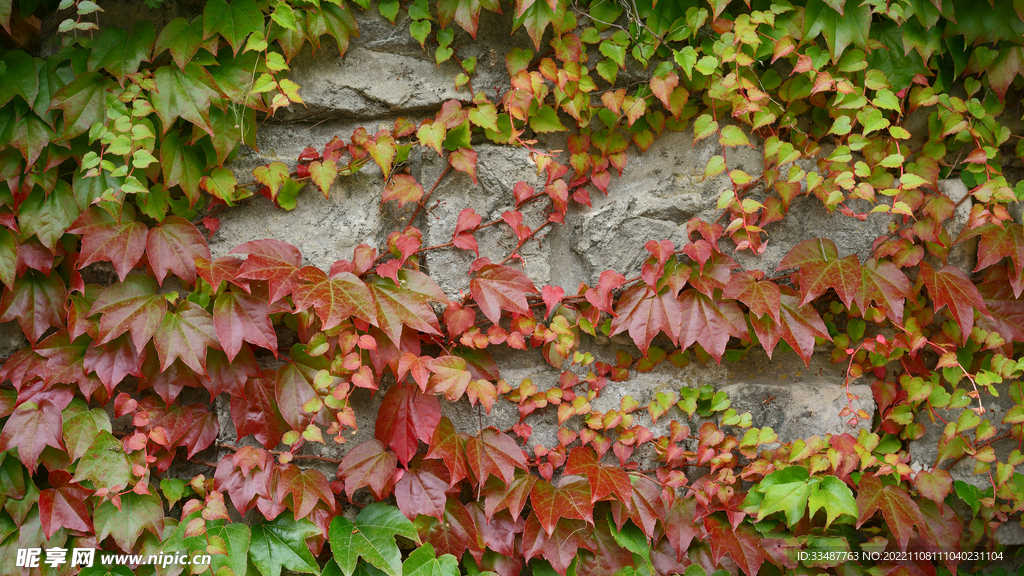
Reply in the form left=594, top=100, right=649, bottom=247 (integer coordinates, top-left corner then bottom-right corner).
left=374, top=384, right=441, bottom=466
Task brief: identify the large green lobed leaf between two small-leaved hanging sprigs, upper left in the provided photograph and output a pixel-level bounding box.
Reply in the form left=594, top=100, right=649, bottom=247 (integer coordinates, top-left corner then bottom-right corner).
left=150, top=63, right=221, bottom=134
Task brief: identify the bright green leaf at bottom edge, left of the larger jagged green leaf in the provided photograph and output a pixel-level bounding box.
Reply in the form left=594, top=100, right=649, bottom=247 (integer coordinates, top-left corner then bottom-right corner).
left=249, top=511, right=321, bottom=576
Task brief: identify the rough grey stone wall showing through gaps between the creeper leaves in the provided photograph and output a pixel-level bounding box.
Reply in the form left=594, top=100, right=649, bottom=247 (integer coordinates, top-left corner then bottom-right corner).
left=37, top=0, right=1024, bottom=528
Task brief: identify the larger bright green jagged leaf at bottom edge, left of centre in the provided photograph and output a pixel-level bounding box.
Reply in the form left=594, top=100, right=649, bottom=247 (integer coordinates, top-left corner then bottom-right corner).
left=330, top=502, right=419, bottom=576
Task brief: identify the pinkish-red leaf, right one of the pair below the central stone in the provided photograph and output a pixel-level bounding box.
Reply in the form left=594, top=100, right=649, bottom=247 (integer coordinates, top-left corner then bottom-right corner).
left=679, top=289, right=748, bottom=362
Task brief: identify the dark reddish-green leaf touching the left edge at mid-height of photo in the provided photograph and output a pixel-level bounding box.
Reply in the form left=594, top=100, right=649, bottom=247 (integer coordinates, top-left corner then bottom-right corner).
left=0, top=270, right=68, bottom=344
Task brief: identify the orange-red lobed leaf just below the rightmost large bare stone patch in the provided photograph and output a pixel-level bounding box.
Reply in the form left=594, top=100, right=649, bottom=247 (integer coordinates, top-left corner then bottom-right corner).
left=778, top=238, right=860, bottom=307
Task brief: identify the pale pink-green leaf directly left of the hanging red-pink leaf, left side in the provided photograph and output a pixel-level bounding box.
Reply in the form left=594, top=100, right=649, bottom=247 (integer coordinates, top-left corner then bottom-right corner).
left=153, top=300, right=219, bottom=374
